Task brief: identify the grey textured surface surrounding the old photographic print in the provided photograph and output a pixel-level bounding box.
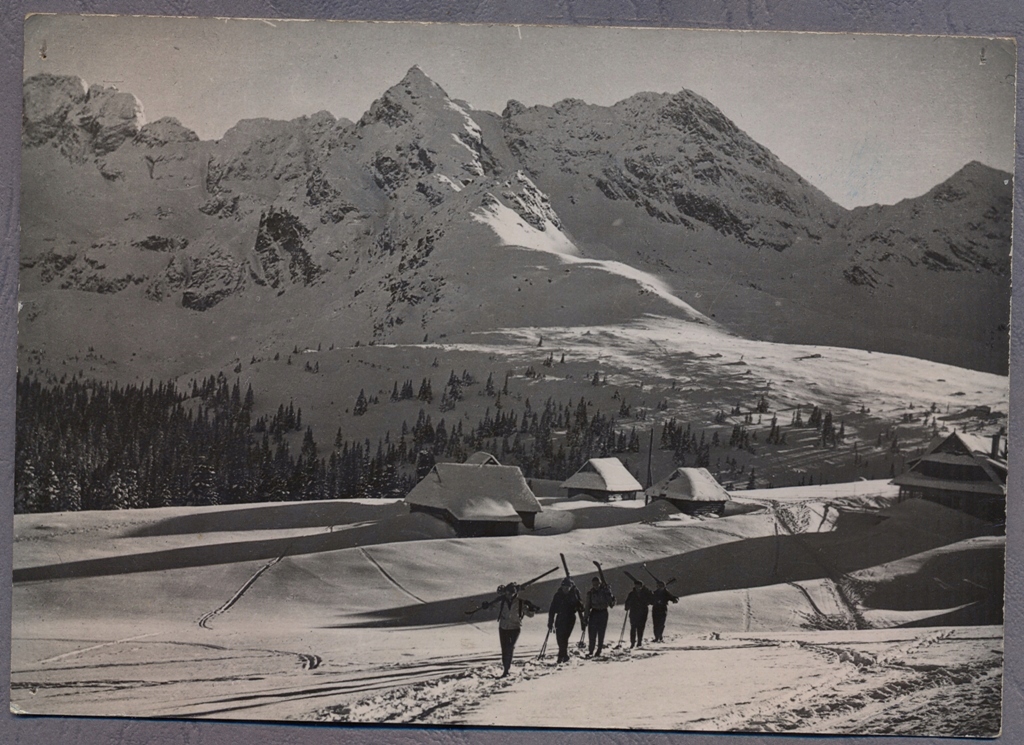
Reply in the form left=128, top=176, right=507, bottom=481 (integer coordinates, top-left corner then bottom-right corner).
left=0, top=0, right=1024, bottom=745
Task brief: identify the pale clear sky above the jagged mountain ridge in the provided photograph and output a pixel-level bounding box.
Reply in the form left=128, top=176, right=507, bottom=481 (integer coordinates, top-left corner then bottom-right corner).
left=25, top=15, right=1016, bottom=208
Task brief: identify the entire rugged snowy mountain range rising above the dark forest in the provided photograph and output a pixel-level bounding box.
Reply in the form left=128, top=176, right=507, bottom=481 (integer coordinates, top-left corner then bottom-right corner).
left=22, top=68, right=1011, bottom=369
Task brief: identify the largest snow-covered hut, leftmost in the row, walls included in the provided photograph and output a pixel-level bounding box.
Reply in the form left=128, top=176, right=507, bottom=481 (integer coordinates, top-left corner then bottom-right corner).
left=406, top=463, right=541, bottom=537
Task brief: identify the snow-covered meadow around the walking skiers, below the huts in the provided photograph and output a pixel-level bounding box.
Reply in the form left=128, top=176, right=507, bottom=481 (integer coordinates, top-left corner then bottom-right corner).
left=11, top=474, right=1004, bottom=735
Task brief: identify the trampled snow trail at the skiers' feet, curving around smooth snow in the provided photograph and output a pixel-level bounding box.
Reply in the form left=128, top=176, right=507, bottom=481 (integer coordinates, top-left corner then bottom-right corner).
left=312, top=629, right=999, bottom=733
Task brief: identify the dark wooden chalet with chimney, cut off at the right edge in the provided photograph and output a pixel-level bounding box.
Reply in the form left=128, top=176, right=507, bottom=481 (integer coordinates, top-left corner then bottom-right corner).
left=892, top=432, right=1007, bottom=523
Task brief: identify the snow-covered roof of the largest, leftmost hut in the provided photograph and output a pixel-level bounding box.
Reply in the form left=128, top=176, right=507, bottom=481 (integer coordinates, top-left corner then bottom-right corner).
left=406, top=463, right=541, bottom=521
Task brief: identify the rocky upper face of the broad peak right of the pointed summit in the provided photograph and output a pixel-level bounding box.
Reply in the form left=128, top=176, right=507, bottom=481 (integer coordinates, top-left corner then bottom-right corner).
left=502, top=91, right=842, bottom=251
